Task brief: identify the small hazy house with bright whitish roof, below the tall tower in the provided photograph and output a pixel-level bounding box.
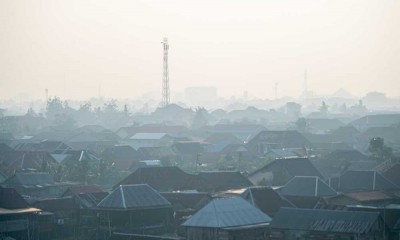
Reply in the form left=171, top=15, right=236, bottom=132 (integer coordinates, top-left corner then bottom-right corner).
left=126, top=133, right=174, bottom=149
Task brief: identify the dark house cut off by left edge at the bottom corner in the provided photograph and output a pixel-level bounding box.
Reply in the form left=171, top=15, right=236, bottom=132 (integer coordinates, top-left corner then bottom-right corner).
left=0, top=187, right=41, bottom=240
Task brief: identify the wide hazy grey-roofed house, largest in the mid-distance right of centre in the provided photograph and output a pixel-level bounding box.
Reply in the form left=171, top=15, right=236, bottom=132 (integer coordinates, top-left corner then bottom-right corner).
left=247, top=131, right=312, bottom=155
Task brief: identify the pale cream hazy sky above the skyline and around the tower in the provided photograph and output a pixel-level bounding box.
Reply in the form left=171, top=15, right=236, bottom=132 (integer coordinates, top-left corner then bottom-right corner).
left=0, top=0, right=400, bottom=99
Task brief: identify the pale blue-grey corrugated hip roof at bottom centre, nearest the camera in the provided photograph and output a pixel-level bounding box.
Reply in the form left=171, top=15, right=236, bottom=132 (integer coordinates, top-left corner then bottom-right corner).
left=182, top=197, right=271, bottom=228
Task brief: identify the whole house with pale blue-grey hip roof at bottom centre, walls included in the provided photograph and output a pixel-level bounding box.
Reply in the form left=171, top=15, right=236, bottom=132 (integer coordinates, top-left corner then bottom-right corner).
left=182, top=197, right=271, bottom=240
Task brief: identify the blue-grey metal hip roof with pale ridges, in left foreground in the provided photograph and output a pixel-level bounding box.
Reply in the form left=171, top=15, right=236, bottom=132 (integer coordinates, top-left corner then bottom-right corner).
left=97, top=184, right=171, bottom=210
